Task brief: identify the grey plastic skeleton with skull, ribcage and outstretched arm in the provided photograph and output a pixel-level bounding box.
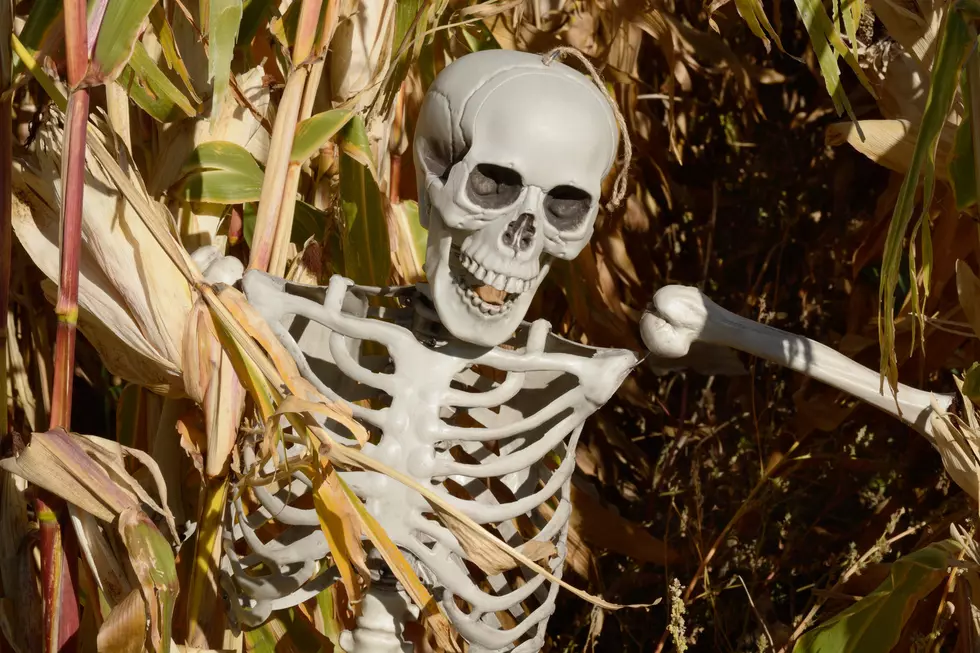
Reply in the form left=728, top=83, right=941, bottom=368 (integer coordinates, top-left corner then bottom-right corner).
left=211, top=51, right=950, bottom=653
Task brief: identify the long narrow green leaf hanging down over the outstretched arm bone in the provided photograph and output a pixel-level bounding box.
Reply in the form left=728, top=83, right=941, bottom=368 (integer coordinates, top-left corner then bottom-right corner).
left=878, top=10, right=972, bottom=389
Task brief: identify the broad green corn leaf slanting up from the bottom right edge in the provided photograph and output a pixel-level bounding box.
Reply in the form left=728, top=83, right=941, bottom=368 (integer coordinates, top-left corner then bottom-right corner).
left=793, top=540, right=959, bottom=653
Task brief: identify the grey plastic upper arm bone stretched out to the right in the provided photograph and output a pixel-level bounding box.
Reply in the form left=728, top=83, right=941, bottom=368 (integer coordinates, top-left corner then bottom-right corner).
left=640, top=286, right=954, bottom=442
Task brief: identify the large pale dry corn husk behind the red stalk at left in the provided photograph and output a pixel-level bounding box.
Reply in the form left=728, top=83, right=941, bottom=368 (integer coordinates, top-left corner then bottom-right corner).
left=13, top=111, right=191, bottom=395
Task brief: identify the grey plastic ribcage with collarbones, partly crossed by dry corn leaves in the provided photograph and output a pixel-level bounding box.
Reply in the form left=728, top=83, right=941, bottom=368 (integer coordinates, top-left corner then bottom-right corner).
left=224, top=272, right=637, bottom=651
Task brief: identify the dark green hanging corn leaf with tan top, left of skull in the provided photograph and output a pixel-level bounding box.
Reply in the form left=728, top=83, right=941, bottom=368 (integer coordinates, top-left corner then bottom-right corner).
left=340, top=116, right=391, bottom=286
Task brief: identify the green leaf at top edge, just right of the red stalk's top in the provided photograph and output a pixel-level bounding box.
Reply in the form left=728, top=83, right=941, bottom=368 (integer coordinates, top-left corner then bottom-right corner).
left=89, top=0, right=163, bottom=81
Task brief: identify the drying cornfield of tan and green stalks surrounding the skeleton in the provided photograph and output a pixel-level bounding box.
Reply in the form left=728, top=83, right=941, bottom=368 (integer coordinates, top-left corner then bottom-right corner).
left=9, top=0, right=980, bottom=653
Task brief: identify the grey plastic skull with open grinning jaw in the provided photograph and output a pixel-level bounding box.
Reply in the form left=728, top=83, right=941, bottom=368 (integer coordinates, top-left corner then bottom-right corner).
left=414, top=50, right=619, bottom=346
